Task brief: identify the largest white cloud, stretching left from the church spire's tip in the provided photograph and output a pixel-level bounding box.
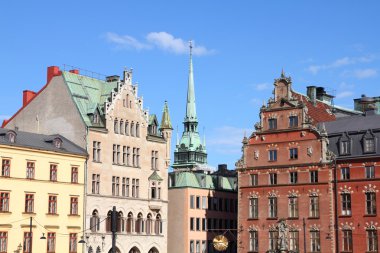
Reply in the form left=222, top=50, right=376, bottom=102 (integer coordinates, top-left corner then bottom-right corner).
left=106, top=32, right=214, bottom=56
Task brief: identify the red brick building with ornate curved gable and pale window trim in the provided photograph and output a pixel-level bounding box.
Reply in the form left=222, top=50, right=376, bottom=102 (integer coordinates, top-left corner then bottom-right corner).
left=237, top=73, right=357, bottom=253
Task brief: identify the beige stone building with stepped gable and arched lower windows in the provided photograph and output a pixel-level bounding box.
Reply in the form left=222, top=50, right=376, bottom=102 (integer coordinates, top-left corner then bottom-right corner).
left=4, top=67, right=172, bottom=253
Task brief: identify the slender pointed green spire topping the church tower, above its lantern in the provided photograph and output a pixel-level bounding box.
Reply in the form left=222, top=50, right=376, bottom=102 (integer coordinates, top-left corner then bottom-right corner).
left=185, top=41, right=197, bottom=122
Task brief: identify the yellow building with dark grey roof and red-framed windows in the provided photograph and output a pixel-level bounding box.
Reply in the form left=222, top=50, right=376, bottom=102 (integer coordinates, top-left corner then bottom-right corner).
left=0, top=128, right=87, bottom=253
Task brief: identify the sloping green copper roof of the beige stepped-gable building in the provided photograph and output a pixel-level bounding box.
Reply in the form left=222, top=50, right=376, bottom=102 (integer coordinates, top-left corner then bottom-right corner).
left=62, top=71, right=117, bottom=127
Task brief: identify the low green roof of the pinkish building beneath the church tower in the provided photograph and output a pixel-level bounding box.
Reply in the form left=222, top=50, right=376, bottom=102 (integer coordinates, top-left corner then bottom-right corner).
left=169, top=171, right=237, bottom=191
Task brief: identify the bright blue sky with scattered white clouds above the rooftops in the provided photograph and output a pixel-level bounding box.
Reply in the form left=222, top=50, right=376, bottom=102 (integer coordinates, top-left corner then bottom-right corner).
left=0, top=0, right=380, bottom=169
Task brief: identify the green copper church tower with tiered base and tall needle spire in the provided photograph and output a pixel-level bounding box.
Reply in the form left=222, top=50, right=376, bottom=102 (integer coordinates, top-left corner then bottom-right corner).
left=172, top=42, right=207, bottom=170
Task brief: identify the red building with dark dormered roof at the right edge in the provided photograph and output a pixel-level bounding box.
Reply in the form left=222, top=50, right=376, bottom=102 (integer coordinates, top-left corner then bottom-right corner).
left=324, top=105, right=380, bottom=252
